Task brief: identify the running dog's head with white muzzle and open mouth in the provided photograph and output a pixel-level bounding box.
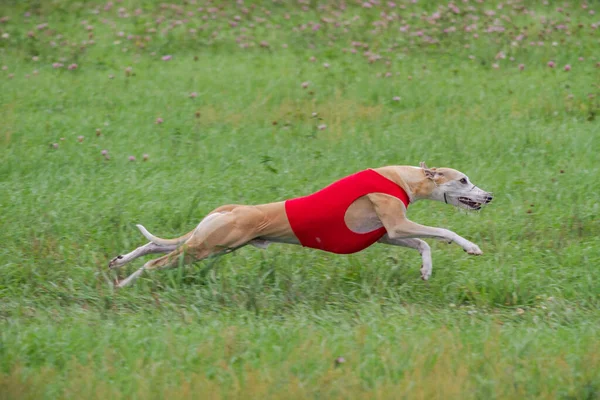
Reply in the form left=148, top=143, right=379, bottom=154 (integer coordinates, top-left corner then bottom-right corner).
left=421, top=162, right=493, bottom=210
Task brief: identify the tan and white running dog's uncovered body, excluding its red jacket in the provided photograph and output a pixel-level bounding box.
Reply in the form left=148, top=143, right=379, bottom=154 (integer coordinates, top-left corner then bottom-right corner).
left=109, top=163, right=492, bottom=287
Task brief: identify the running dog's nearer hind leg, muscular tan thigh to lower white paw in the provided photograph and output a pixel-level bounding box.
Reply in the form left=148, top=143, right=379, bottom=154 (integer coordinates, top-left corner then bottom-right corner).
left=117, top=206, right=264, bottom=287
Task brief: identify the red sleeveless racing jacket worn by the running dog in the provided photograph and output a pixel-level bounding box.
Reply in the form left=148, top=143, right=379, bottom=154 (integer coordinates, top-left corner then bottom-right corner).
left=285, top=169, right=410, bottom=254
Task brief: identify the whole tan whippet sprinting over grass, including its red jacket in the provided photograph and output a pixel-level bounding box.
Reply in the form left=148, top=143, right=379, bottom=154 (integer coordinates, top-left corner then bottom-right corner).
left=109, top=163, right=492, bottom=287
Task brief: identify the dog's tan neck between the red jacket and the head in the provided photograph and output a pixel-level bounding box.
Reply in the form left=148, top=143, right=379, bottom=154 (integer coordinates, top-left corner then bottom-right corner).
left=375, top=165, right=435, bottom=203
